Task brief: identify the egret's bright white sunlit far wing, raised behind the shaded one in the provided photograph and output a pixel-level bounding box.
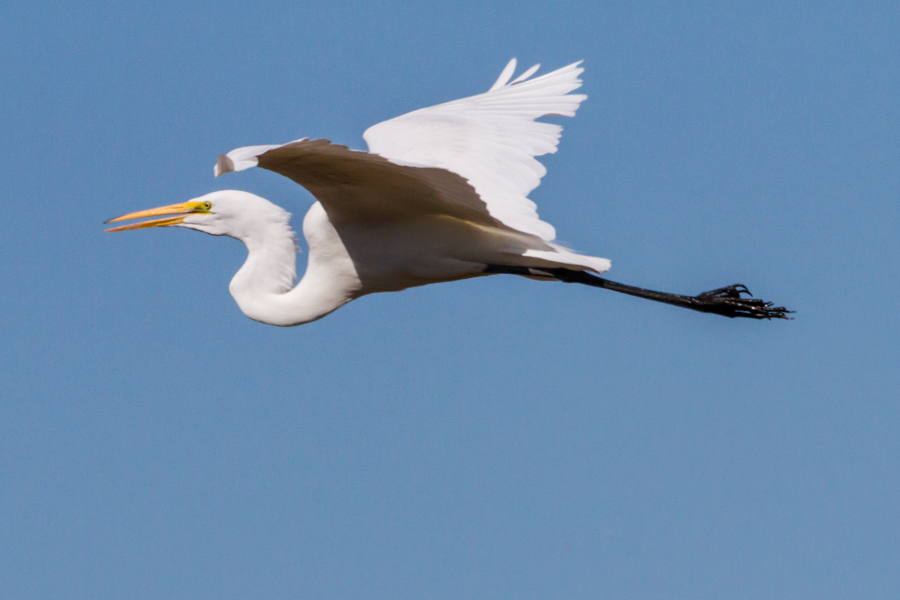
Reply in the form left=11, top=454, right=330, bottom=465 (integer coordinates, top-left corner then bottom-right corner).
left=363, top=59, right=587, bottom=241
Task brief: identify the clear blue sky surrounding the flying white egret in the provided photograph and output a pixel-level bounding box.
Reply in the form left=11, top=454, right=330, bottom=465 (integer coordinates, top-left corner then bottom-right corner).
left=0, top=0, right=900, bottom=600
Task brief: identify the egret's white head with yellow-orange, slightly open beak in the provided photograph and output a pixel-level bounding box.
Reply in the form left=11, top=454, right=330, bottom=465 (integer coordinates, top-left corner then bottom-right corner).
left=106, top=190, right=291, bottom=243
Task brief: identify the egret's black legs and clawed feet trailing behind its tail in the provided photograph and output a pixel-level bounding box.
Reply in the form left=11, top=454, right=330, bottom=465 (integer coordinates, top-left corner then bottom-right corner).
left=484, top=265, right=793, bottom=319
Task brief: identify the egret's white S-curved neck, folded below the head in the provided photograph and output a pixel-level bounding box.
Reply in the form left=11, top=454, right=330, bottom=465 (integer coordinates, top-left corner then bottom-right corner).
left=229, top=211, right=360, bottom=327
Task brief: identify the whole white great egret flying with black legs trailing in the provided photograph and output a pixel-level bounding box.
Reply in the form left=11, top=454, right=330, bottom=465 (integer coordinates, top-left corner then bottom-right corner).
left=107, top=59, right=789, bottom=326
